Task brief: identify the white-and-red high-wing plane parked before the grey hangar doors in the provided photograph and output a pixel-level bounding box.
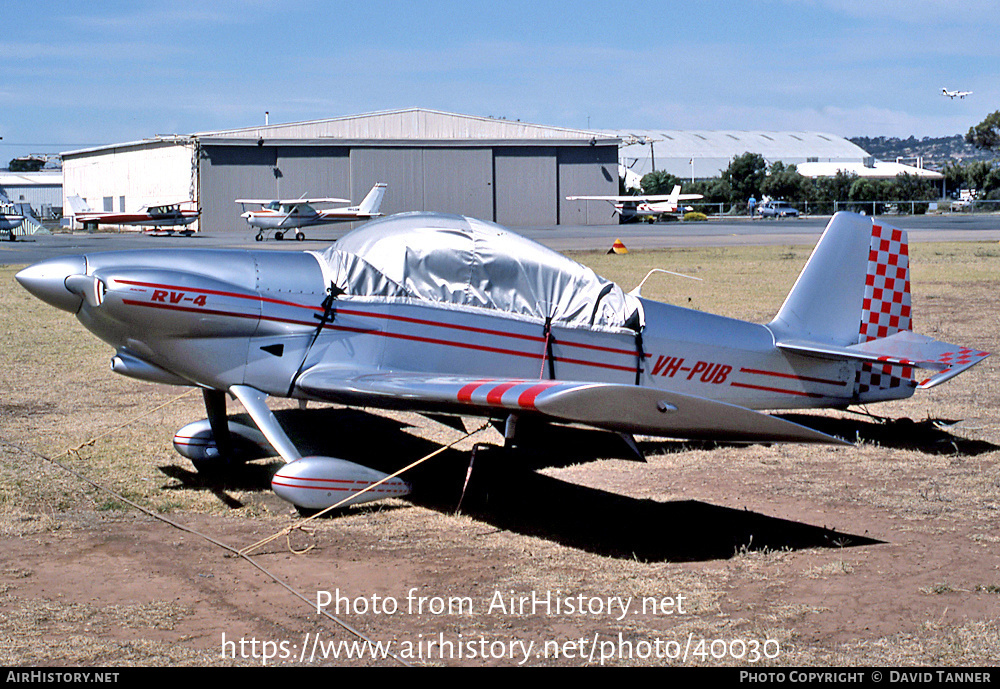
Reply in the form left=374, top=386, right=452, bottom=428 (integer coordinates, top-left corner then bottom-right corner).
left=236, top=182, right=386, bottom=242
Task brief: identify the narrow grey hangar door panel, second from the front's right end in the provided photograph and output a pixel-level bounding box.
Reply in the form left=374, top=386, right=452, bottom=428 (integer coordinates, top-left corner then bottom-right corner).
left=493, top=146, right=559, bottom=227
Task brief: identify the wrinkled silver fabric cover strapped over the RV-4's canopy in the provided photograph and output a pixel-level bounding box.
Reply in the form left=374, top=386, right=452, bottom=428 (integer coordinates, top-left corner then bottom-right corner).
left=317, top=212, right=643, bottom=331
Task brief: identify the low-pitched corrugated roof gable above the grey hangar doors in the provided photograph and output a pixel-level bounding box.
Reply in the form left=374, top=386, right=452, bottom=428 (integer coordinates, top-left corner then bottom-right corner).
left=194, top=108, right=617, bottom=142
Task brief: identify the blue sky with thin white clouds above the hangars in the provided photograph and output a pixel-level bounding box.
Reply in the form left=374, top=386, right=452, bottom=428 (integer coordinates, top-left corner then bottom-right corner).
left=0, top=0, right=1000, bottom=160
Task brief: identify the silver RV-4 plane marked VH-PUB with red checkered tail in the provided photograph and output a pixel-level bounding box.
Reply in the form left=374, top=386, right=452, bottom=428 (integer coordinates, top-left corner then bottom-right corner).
left=17, top=212, right=988, bottom=509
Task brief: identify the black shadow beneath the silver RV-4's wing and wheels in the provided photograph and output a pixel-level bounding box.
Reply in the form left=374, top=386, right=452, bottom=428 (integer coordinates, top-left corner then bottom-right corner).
left=161, top=409, right=908, bottom=562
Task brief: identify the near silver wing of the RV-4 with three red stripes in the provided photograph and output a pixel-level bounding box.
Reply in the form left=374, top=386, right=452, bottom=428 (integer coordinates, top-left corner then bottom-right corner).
left=296, top=365, right=849, bottom=445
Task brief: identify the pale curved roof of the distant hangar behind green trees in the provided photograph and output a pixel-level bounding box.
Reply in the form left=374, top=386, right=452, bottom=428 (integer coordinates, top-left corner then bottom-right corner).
left=605, top=129, right=868, bottom=161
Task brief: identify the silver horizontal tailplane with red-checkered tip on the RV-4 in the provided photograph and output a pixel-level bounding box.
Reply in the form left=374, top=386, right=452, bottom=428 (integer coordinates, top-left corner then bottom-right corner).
left=776, top=330, right=989, bottom=388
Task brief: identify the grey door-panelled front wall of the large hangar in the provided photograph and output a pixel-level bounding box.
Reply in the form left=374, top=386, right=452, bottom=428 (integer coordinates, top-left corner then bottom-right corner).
left=199, top=143, right=618, bottom=232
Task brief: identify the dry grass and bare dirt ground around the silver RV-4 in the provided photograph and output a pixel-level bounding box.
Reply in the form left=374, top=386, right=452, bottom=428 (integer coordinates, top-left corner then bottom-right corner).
left=0, top=244, right=1000, bottom=666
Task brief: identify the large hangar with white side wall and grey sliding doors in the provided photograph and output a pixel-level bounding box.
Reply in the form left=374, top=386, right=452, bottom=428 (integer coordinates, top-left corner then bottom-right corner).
left=62, top=108, right=619, bottom=232
